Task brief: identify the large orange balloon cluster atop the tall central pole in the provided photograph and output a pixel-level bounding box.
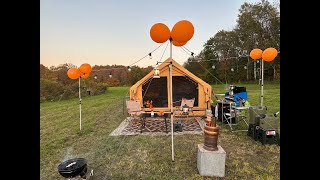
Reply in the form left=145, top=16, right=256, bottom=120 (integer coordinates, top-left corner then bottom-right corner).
left=150, top=20, right=194, bottom=46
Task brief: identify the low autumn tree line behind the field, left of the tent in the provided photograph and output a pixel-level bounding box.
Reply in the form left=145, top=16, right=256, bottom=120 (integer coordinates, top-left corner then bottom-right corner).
left=40, top=63, right=153, bottom=102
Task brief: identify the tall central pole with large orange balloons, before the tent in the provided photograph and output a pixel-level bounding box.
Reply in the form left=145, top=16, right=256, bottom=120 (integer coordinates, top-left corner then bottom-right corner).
left=150, top=20, right=194, bottom=161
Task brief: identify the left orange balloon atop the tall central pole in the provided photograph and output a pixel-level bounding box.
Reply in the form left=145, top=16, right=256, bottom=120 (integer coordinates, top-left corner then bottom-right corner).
left=150, top=23, right=170, bottom=43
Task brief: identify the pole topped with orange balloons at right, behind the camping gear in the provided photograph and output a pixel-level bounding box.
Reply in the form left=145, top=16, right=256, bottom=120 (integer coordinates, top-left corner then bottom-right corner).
left=250, top=47, right=278, bottom=106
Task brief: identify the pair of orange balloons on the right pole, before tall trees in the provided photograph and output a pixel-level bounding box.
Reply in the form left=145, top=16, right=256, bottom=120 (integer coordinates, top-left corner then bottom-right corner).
left=250, top=48, right=278, bottom=62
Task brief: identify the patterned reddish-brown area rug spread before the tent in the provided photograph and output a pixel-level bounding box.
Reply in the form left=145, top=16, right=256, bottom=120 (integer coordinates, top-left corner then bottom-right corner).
left=110, top=117, right=204, bottom=136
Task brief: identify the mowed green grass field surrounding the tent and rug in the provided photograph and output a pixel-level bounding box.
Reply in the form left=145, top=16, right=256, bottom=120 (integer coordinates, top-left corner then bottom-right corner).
left=40, top=84, right=280, bottom=180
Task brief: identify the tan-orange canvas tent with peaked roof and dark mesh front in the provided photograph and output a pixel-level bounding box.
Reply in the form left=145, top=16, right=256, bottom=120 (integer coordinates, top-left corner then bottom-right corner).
left=130, top=58, right=213, bottom=116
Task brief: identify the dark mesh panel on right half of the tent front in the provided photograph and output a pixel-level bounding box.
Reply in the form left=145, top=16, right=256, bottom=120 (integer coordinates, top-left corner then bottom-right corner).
left=172, top=76, right=198, bottom=107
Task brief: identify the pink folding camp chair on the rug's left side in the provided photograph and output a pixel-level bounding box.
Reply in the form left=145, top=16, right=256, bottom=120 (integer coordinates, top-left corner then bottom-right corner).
left=126, top=100, right=146, bottom=133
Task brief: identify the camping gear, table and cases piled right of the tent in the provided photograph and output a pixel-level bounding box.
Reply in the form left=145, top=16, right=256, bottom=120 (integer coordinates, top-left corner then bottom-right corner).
left=216, top=85, right=280, bottom=145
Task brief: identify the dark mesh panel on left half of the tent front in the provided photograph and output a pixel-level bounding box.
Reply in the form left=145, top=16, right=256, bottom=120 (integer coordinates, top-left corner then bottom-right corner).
left=142, top=77, right=168, bottom=107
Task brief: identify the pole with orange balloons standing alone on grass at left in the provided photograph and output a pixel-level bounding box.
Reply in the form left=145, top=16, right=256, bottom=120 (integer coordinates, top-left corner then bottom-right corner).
left=67, top=63, right=92, bottom=131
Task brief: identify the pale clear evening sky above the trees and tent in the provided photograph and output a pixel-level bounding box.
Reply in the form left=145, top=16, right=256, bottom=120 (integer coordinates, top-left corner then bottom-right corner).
left=40, top=0, right=272, bottom=67
